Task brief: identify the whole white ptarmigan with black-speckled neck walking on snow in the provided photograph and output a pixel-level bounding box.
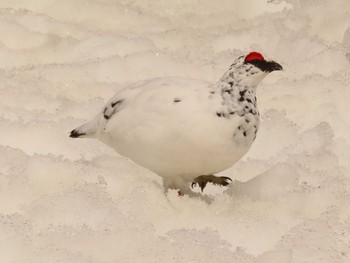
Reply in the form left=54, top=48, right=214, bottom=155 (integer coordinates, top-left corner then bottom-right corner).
left=70, top=52, right=282, bottom=194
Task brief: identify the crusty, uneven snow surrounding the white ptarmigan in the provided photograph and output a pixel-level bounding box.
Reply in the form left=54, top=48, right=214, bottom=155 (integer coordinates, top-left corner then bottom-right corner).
left=0, top=0, right=350, bottom=263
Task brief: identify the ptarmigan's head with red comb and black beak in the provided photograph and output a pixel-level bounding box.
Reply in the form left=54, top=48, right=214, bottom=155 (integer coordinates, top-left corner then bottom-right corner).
left=221, top=52, right=283, bottom=86
